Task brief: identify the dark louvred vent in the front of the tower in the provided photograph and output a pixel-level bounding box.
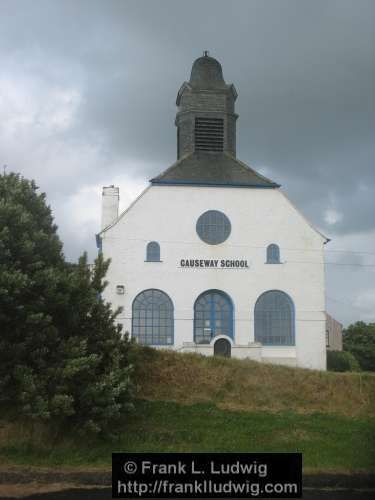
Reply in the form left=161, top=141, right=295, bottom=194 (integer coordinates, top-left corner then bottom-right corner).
left=195, top=118, right=224, bottom=151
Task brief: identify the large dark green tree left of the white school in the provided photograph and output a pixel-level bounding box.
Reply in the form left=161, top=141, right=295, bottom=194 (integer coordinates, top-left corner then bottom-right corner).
left=0, top=173, right=132, bottom=433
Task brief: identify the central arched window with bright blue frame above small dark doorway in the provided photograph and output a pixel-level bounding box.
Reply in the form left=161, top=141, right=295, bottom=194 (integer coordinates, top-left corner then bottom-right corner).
left=194, top=290, right=233, bottom=344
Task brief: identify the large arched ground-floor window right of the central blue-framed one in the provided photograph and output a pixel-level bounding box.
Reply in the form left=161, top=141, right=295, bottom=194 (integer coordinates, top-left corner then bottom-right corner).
left=254, top=290, right=295, bottom=345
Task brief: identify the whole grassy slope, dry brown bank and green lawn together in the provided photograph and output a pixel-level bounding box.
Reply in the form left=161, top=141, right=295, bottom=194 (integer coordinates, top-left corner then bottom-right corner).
left=0, top=348, right=375, bottom=472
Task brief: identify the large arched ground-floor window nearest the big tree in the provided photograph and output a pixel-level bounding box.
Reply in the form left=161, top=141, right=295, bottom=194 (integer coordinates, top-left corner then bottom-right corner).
left=132, top=289, right=174, bottom=345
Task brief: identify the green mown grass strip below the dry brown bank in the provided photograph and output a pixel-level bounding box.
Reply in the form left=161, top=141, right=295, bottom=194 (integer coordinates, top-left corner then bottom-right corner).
left=0, top=401, right=375, bottom=472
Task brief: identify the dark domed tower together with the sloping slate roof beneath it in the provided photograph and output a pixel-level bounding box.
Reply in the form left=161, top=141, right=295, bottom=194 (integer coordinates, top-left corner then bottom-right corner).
left=151, top=51, right=280, bottom=189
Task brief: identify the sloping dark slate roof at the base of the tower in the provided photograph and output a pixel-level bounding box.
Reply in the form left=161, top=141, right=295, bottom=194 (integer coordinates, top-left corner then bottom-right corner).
left=150, top=152, right=280, bottom=188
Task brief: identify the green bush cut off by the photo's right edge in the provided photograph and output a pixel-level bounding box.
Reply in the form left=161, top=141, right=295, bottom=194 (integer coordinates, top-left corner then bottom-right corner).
left=343, top=321, right=375, bottom=371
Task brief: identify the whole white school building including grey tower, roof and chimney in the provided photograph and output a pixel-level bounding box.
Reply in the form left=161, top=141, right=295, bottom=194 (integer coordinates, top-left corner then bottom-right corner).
left=97, top=53, right=328, bottom=370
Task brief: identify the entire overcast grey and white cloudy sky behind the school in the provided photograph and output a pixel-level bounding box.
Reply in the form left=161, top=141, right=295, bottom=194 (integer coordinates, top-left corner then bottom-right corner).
left=0, top=0, right=375, bottom=324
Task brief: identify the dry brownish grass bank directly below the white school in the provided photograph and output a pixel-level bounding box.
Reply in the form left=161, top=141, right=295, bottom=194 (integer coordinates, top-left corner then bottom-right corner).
left=137, top=349, right=375, bottom=417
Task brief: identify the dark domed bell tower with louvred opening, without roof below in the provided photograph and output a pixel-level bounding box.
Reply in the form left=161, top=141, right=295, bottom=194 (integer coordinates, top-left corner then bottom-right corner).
left=175, top=51, right=238, bottom=159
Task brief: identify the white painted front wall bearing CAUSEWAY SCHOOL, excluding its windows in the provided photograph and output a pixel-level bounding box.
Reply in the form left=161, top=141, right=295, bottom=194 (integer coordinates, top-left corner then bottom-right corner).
left=102, top=185, right=326, bottom=369
